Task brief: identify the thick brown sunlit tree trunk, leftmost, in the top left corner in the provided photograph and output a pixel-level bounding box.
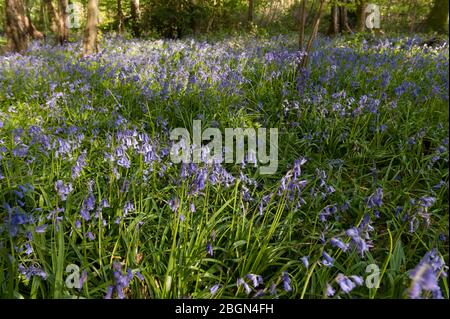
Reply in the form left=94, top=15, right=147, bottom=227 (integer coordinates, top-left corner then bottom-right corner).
left=5, top=0, right=28, bottom=52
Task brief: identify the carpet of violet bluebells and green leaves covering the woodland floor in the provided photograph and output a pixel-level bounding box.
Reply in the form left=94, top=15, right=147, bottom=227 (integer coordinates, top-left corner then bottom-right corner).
left=0, top=35, right=449, bottom=298
